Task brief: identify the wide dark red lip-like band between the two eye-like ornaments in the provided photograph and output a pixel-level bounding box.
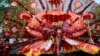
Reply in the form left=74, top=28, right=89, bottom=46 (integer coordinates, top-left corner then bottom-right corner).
left=43, top=14, right=71, bottom=22
